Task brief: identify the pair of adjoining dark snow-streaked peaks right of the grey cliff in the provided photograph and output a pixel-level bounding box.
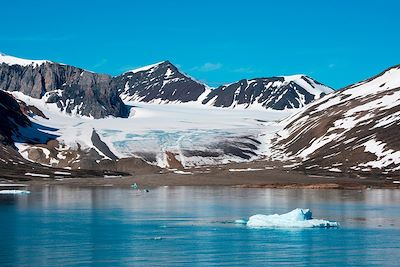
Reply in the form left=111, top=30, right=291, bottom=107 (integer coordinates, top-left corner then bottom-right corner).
left=114, top=61, right=333, bottom=110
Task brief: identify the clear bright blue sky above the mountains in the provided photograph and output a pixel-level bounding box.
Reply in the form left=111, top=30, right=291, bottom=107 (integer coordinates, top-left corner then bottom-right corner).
left=0, top=0, right=400, bottom=88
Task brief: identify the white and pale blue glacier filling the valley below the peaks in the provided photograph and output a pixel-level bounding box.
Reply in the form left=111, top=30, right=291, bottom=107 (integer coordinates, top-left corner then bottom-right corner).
left=12, top=92, right=294, bottom=168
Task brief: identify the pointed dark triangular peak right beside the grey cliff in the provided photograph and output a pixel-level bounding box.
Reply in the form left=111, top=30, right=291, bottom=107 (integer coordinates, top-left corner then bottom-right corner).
left=114, top=61, right=206, bottom=102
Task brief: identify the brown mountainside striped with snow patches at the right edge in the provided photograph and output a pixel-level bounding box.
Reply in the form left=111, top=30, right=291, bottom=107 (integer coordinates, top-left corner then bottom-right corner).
left=275, top=65, right=400, bottom=175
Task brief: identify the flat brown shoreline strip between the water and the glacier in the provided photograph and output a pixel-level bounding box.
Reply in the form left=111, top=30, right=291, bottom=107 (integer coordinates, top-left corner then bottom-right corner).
left=0, top=161, right=400, bottom=190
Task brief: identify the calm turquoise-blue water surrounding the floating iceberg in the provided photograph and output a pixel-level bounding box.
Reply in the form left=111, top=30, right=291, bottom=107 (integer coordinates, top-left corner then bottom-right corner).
left=0, top=186, right=400, bottom=266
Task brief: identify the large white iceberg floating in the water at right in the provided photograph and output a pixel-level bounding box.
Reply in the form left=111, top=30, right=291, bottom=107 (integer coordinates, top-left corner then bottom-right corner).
left=246, top=208, right=339, bottom=228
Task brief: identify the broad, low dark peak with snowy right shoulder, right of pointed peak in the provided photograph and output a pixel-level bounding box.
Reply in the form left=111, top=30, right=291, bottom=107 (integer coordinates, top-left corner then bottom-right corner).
left=202, top=75, right=333, bottom=110
